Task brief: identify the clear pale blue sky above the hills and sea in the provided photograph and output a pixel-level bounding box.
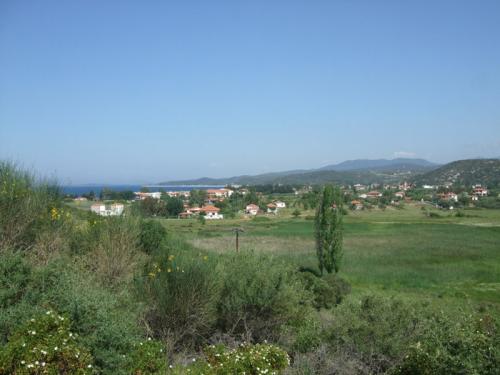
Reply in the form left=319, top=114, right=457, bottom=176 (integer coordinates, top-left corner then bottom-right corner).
left=0, top=0, right=500, bottom=184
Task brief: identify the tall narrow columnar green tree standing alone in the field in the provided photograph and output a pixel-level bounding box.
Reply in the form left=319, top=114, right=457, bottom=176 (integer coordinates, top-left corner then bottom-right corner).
left=314, top=185, right=343, bottom=274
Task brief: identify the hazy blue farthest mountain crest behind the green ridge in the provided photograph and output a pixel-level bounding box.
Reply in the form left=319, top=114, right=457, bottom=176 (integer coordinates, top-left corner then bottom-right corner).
left=319, top=158, right=438, bottom=171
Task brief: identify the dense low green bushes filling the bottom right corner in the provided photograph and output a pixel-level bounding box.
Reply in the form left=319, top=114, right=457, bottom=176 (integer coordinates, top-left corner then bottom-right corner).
left=327, top=295, right=500, bottom=374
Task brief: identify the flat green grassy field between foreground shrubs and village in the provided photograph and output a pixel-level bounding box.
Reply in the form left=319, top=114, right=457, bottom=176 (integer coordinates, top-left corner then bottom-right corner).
left=163, top=205, right=500, bottom=312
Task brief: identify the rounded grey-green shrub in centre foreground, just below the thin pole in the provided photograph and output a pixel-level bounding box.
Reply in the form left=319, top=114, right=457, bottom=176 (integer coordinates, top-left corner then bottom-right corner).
left=218, top=253, right=307, bottom=341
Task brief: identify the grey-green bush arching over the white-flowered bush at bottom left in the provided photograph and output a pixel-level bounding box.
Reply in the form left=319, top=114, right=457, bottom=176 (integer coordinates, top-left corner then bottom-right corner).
left=0, top=254, right=140, bottom=374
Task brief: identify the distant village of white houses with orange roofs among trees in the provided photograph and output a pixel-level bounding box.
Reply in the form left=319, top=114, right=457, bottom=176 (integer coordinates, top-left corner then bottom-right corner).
left=74, top=181, right=496, bottom=220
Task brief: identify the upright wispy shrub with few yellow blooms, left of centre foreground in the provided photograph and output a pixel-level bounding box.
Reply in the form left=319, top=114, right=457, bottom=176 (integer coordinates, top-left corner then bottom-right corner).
left=137, top=245, right=220, bottom=347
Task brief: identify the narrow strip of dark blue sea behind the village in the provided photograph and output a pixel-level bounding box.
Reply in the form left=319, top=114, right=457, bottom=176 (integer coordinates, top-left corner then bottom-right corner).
left=62, top=185, right=224, bottom=196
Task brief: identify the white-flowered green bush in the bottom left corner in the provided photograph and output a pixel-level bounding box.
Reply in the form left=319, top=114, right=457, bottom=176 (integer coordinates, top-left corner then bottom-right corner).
left=0, top=310, right=93, bottom=374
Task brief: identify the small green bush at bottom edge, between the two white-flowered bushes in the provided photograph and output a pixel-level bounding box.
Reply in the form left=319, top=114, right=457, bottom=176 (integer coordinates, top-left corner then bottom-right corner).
left=127, top=338, right=167, bottom=375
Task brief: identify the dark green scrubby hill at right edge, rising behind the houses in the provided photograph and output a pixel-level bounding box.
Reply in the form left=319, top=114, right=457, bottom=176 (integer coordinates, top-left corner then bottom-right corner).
left=414, top=159, right=500, bottom=187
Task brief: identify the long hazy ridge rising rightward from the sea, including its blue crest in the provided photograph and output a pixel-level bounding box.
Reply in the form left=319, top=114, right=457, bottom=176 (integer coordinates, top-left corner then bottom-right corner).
left=160, top=158, right=437, bottom=185
